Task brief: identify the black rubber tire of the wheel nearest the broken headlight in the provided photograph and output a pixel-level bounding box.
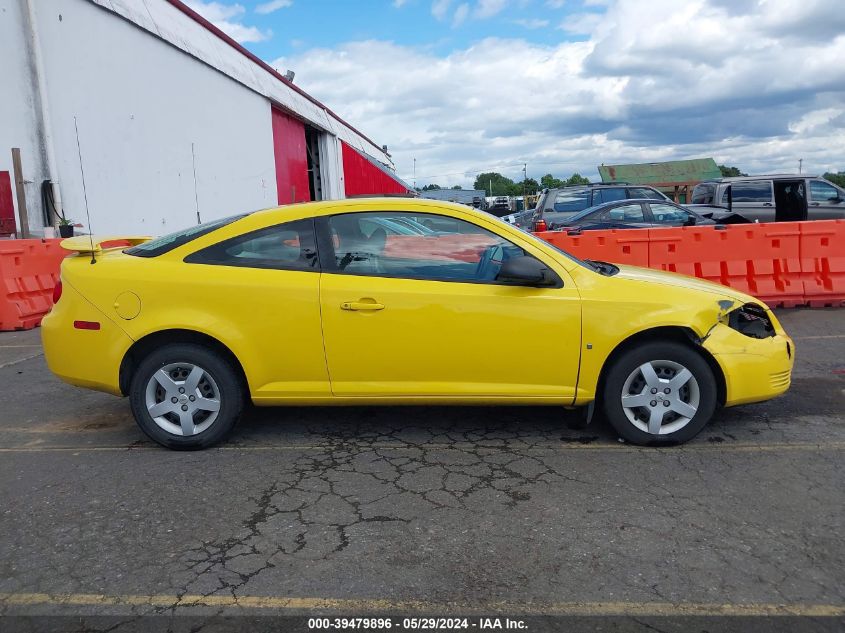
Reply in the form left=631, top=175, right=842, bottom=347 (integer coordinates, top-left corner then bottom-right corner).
left=602, top=342, right=717, bottom=445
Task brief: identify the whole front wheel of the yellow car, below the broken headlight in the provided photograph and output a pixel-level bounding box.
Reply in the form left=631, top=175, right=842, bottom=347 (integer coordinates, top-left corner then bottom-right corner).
left=603, top=342, right=716, bottom=444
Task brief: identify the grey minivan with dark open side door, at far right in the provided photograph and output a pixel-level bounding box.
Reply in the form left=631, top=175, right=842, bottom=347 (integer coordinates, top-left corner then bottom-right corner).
left=692, top=174, right=845, bottom=222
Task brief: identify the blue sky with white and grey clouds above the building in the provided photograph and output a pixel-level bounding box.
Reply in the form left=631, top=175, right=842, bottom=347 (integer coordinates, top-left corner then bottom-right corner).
left=188, top=0, right=845, bottom=187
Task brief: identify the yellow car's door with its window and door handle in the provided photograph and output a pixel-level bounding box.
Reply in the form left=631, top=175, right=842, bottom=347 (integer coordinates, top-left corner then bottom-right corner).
left=317, top=211, right=581, bottom=402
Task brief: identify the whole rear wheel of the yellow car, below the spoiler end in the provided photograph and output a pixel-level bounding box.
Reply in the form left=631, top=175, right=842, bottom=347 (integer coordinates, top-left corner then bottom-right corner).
left=129, top=344, right=244, bottom=450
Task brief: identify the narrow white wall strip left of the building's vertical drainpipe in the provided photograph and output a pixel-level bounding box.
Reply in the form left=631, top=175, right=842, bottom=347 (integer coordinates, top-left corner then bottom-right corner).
left=0, top=0, right=47, bottom=233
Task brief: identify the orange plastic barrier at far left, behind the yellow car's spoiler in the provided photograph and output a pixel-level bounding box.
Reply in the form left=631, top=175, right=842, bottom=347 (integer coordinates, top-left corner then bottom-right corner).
left=0, top=239, right=68, bottom=331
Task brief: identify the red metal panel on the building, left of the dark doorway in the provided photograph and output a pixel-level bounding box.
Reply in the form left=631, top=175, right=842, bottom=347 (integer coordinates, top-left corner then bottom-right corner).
left=272, top=108, right=311, bottom=204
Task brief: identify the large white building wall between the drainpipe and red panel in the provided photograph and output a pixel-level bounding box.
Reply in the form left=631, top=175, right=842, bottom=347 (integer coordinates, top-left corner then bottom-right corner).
left=29, top=0, right=277, bottom=235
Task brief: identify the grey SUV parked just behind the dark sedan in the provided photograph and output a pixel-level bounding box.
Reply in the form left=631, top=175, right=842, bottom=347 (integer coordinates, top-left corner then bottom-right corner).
left=502, top=183, right=669, bottom=231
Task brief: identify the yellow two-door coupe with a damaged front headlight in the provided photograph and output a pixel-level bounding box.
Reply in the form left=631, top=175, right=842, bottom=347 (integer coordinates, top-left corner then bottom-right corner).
left=42, top=198, right=794, bottom=449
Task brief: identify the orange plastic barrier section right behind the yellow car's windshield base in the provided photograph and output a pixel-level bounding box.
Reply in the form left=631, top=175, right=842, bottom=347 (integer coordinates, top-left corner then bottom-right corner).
left=535, top=229, right=649, bottom=266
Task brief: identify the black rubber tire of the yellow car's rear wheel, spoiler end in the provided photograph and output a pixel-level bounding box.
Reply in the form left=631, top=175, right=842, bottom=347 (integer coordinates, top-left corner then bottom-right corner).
left=129, top=343, right=245, bottom=450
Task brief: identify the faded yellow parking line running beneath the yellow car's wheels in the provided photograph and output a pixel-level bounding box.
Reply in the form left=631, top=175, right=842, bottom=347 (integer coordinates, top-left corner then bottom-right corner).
left=0, top=441, right=845, bottom=455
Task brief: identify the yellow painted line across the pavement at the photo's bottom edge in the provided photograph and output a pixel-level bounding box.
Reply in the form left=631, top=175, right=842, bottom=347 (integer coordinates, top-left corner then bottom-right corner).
left=0, top=593, right=845, bottom=617
